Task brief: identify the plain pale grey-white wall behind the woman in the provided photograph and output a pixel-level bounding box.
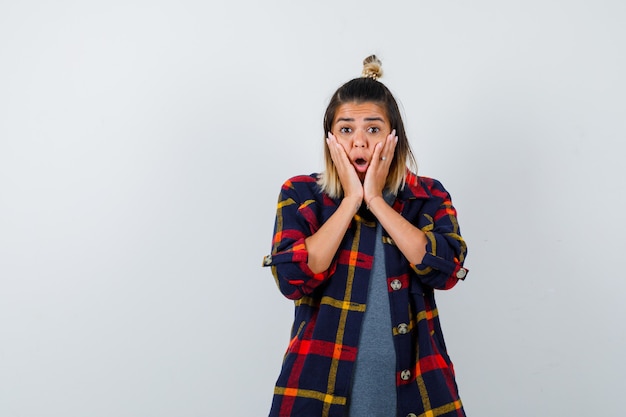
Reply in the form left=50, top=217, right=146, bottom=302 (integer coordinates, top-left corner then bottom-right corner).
left=0, top=0, right=626, bottom=417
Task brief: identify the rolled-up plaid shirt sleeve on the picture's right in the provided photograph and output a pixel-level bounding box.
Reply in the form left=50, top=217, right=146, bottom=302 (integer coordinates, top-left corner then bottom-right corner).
left=411, top=182, right=468, bottom=290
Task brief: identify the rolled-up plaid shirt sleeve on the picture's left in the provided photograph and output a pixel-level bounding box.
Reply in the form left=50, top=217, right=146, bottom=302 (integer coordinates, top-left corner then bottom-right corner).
left=263, top=177, right=336, bottom=300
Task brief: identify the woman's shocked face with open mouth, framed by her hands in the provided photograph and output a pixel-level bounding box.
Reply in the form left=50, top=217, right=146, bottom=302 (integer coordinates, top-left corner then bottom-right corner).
left=331, top=102, right=391, bottom=180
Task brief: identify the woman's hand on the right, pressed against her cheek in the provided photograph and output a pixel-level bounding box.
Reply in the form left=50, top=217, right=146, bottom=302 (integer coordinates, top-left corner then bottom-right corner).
left=363, top=129, right=398, bottom=205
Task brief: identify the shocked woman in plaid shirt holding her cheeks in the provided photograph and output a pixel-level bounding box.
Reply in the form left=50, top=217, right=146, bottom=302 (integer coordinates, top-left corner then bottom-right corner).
left=264, top=56, right=467, bottom=417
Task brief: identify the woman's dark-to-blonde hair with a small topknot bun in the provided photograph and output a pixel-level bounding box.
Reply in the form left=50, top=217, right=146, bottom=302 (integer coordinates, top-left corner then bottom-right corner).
left=317, top=55, right=417, bottom=198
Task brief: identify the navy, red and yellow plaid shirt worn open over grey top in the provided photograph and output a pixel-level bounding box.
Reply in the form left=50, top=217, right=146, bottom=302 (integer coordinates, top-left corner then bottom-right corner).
left=264, top=173, right=467, bottom=417
